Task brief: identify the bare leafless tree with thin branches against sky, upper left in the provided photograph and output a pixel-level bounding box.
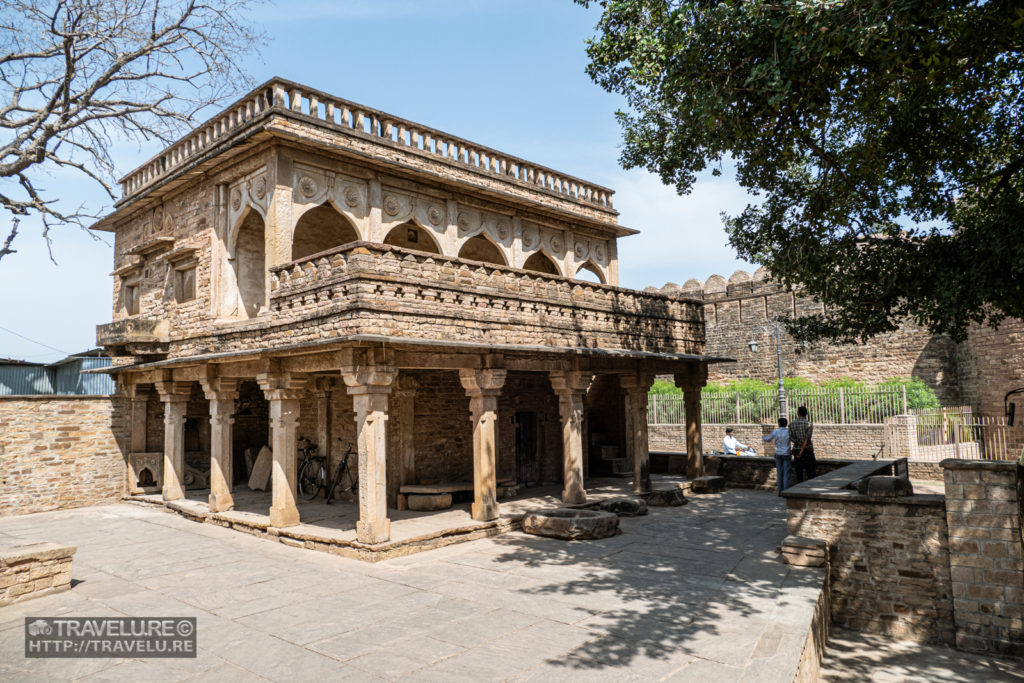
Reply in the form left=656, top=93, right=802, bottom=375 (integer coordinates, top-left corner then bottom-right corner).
left=0, top=0, right=260, bottom=259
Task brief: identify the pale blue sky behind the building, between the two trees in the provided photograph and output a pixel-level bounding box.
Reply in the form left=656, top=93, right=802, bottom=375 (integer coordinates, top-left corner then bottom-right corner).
left=0, top=0, right=754, bottom=360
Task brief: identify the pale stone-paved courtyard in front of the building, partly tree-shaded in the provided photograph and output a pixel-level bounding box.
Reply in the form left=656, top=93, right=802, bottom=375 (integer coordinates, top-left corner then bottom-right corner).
left=0, top=490, right=823, bottom=683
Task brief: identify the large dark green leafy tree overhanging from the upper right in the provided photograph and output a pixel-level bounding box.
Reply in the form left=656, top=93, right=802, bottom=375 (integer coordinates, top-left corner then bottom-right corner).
left=577, top=0, right=1024, bottom=341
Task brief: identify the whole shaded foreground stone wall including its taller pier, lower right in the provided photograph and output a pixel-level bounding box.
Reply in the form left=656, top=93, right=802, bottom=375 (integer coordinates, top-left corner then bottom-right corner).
left=786, top=459, right=1024, bottom=656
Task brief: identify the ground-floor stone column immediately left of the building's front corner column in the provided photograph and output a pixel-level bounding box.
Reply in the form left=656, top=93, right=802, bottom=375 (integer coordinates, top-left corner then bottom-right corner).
left=256, top=373, right=306, bottom=526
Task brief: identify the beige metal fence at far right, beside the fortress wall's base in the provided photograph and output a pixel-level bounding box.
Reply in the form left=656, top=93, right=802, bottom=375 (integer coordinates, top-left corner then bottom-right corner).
left=886, top=407, right=1017, bottom=462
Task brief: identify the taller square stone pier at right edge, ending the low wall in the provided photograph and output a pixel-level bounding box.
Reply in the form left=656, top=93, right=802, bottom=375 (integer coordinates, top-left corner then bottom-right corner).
left=942, top=460, right=1024, bottom=656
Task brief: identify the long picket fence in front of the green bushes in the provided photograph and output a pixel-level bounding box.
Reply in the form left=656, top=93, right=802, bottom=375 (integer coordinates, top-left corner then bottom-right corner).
left=647, top=387, right=906, bottom=425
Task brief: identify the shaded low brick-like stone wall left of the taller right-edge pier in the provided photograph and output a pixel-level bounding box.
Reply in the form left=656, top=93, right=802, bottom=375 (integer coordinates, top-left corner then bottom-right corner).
left=786, top=496, right=954, bottom=644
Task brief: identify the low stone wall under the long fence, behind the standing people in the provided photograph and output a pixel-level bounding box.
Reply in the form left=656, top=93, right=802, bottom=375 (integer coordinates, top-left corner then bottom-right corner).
left=647, top=424, right=886, bottom=459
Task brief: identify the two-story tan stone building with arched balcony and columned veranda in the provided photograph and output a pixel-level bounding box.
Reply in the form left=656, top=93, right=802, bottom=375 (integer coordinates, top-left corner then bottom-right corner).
left=96, top=79, right=714, bottom=545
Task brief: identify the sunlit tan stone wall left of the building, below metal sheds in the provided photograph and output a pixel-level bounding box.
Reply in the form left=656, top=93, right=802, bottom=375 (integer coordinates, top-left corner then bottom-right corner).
left=0, top=396, right=127, bottom=516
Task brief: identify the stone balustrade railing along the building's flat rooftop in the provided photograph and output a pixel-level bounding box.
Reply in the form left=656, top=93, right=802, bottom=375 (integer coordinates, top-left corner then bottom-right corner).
left=121, top=79, right=613, bottom=211
